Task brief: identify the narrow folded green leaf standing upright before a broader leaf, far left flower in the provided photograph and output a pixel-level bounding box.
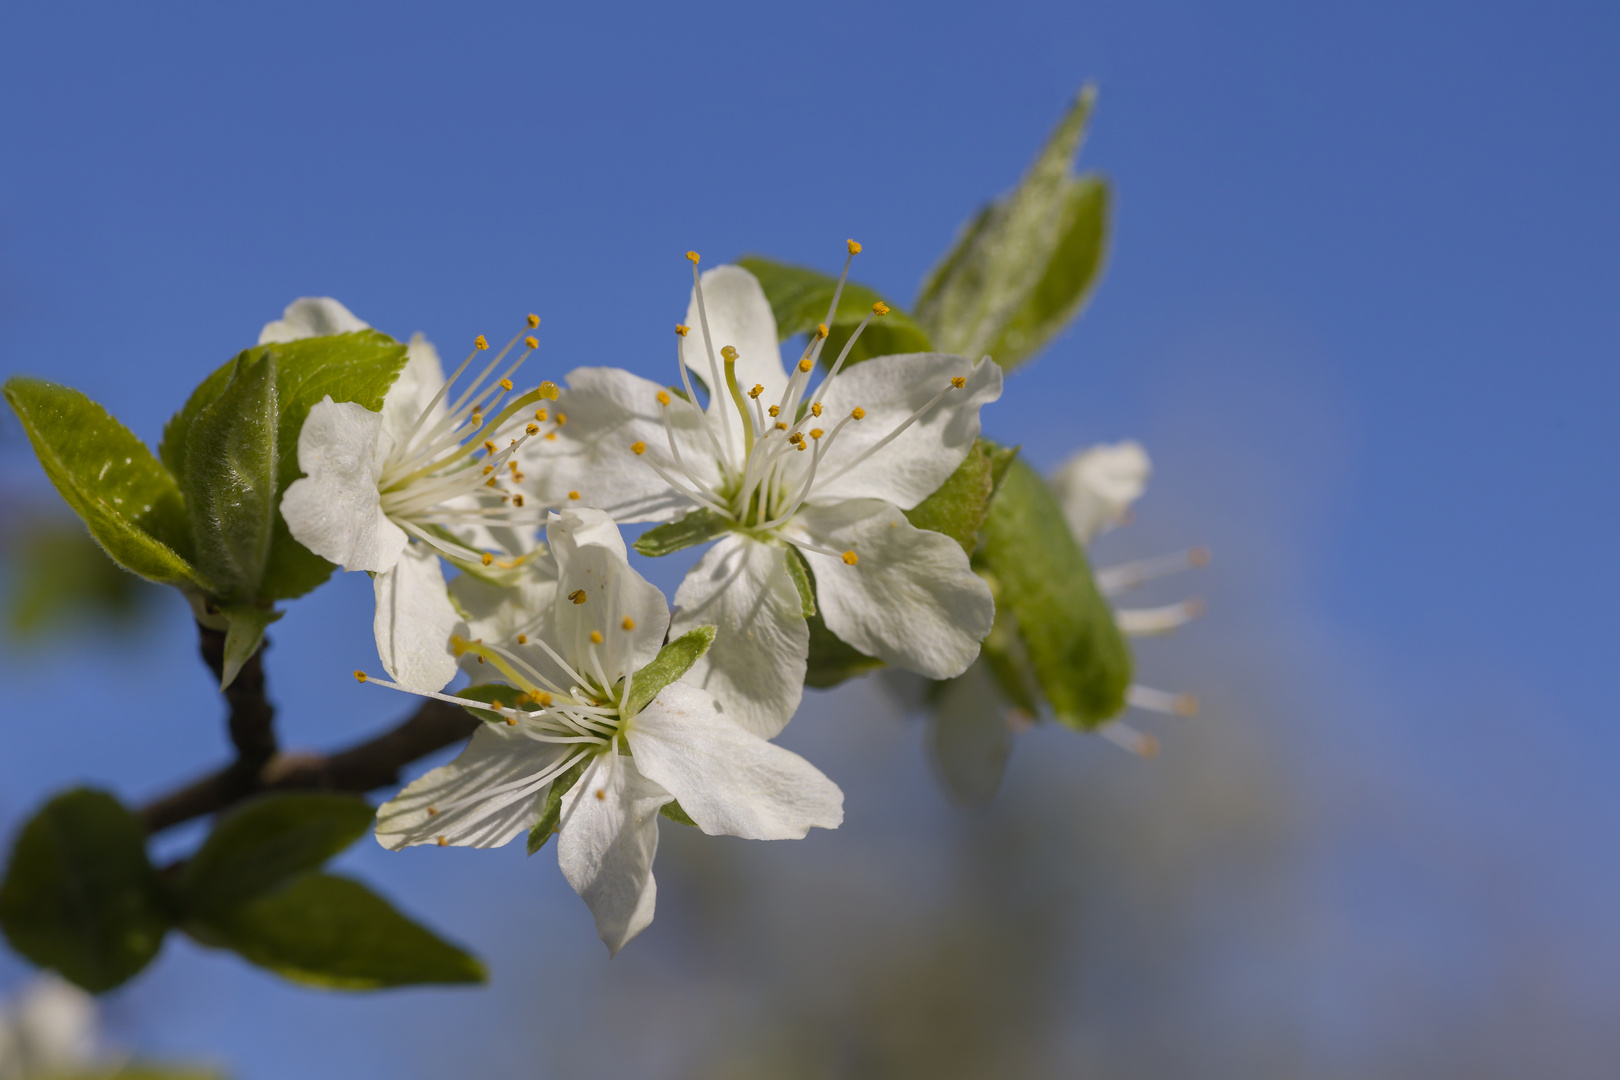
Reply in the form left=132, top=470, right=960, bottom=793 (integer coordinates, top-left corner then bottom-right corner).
left=180, top=353, right=280, bottom=602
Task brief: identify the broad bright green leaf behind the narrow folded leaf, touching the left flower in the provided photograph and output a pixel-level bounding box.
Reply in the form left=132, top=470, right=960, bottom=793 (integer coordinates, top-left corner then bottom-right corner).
left=159, top=330, right=407, bottom=601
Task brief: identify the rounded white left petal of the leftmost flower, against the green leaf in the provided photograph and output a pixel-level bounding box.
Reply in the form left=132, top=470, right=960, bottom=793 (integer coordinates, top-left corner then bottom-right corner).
left=282, top=395, right=407, bottom=572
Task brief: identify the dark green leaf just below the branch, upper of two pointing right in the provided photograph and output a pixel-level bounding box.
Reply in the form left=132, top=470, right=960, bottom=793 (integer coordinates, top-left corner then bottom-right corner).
left=175, top=792, right=376, bottom=918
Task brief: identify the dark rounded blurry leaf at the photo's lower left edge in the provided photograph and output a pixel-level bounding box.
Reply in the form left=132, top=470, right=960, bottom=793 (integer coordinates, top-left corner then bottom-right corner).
left=0, top=789, right=170, bottom=993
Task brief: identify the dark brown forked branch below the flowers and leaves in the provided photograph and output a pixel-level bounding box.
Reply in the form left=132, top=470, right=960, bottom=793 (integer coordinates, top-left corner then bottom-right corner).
left=139, top=627, right=478, bottom=832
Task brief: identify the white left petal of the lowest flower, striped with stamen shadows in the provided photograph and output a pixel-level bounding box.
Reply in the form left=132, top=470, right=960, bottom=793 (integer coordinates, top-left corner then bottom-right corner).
left=377, top=725, right=569, bottom=852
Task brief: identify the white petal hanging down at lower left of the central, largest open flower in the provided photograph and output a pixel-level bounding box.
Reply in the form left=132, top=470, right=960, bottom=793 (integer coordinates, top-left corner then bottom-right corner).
left=669, top=534, right=806, bottom=738
